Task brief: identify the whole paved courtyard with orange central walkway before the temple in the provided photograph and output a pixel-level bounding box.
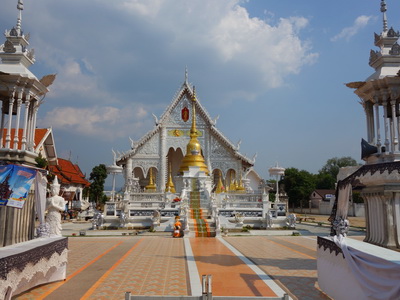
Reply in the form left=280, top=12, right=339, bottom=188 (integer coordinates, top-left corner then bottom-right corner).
left=15, top=219, right=364, bottom=300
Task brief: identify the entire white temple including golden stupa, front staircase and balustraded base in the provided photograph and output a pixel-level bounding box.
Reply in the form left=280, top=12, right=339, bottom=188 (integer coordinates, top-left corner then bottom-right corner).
left=105, top=72, right=287, bottom=236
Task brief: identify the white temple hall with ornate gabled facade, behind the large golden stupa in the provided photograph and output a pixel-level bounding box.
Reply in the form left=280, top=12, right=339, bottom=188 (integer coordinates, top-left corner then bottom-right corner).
left=116, top=73, right=261, bottom=192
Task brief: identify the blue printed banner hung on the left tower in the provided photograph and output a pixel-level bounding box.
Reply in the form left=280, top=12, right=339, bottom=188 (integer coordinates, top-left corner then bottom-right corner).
left=0, top=165, right=36, bottom=208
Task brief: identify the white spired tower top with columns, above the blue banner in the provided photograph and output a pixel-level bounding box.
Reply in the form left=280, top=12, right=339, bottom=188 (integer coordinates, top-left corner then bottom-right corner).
left=0, top=0, right=55, bottom=164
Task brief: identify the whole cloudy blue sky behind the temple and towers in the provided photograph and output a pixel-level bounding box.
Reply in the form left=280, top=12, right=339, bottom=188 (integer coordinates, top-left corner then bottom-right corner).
left=0, top=0, right=400, bottom=188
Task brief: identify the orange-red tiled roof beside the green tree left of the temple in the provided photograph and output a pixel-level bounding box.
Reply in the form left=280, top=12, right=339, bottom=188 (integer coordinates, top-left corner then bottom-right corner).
left=49, top=158, right=90, bottom=187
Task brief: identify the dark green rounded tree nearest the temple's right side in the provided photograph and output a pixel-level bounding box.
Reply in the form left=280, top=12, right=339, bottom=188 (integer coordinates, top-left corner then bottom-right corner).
left=283, top=168, right=316, bottom=207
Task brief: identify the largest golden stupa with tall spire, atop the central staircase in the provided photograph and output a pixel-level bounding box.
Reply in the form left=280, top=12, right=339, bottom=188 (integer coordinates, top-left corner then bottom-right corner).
left=179, top=87, right=209, bottom=175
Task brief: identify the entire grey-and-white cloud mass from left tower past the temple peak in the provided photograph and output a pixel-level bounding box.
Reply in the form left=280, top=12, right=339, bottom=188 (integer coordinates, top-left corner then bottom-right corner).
left=10, top=0, right=318, bottom=137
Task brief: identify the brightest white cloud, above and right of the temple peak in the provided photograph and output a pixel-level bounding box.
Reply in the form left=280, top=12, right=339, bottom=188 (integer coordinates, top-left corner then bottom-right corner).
left=117, top=0, right=318, bottom=89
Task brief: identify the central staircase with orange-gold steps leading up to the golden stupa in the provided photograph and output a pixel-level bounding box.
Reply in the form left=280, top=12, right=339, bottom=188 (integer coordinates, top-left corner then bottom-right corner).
left=189, top=182, right=216, bottom=237
